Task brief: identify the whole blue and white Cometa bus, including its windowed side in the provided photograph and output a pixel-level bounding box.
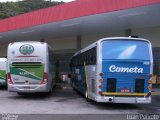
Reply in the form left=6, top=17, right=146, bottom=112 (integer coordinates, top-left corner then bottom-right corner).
left=70, top=37, right=153, bottom=103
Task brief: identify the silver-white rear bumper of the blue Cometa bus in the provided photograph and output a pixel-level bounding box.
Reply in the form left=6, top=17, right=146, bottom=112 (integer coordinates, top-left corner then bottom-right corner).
left=95, top=96, right=151, bottom=103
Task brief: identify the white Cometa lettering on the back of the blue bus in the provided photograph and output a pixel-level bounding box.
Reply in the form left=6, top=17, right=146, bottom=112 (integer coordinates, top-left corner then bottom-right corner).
left=109, top=65, right=143, bottom=73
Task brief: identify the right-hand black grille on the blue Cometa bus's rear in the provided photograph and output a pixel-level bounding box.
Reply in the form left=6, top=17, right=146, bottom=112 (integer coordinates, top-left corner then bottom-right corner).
left=135, top=79, right=144, bottom=93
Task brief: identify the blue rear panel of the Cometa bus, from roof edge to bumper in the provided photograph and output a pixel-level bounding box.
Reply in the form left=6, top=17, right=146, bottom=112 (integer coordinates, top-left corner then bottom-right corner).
left=95, top=39, right=153, bottom=103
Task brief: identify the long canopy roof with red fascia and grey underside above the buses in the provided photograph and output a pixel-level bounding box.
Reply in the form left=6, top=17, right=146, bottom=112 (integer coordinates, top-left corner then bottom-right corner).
left=0, top=0, right=160, bottom=42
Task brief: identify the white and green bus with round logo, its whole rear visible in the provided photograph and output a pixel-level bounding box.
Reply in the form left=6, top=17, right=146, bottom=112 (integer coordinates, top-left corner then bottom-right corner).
left=7, top=41, right=55, bottom=94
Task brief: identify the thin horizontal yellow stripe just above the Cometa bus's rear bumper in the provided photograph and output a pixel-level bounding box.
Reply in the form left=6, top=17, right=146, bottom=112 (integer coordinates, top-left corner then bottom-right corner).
left=102, top=92, right=147, bottom=96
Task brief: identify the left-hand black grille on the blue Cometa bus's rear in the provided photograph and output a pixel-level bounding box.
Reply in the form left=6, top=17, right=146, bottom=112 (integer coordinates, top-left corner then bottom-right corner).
left=107, top=78, right=117, bottom=92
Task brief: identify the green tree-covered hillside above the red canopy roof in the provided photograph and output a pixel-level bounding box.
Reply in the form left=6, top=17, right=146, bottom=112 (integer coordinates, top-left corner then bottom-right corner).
left=0, top=0, right=64, bottom=19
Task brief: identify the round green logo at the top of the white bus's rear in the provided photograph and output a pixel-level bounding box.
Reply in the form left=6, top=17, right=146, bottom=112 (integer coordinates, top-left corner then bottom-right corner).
left=19, top=44, right=34, bottom=55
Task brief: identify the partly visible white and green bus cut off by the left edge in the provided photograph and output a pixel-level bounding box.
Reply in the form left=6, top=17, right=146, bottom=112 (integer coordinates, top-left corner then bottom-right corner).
left=0, top=58, right=7, bottom=86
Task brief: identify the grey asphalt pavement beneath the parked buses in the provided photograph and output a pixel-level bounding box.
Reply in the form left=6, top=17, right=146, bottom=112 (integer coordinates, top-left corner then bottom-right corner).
left=0, top=84, right=160, bottom=120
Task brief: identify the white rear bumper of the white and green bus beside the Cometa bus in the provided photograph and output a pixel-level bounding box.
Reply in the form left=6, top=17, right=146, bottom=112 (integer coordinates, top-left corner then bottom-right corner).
left=8, top=84, right=49, bottom=93
